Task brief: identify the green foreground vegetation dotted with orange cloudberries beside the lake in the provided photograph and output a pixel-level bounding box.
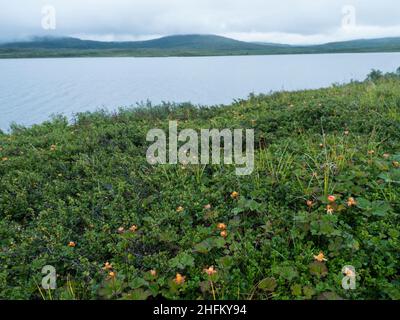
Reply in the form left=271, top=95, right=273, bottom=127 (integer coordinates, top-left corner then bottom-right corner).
left=0, top=72, right=400, bottom=300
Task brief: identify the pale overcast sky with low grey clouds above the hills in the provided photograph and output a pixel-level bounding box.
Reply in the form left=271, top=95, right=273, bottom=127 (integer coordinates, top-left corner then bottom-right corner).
left=0, top=0, right=400, bottom=44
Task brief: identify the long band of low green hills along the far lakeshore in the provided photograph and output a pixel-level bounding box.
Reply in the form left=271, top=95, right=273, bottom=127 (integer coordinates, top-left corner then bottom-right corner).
left=0, top=34, right=400, bottom=58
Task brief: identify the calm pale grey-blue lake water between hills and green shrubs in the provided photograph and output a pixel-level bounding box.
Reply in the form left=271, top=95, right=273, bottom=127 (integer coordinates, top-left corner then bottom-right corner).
left=0, top=53, right=400, bottom=130
